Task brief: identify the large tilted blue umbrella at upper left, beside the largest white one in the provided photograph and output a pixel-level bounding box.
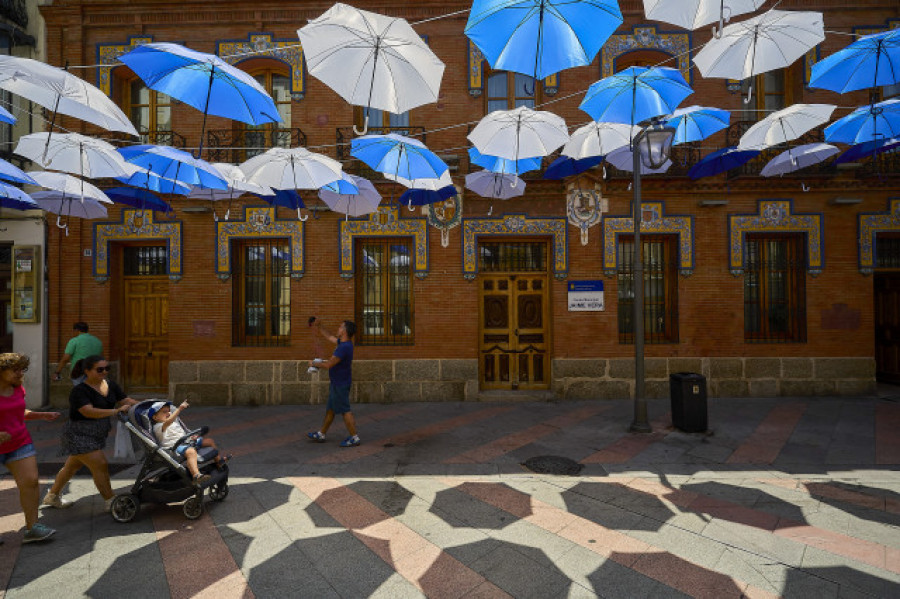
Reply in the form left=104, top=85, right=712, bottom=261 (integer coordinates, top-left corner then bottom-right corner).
left=119, top=42, right=281, bottom=156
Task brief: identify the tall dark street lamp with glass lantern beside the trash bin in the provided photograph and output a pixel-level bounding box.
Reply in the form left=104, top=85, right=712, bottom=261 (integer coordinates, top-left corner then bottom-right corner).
left=629, top=119, right=675, bottom=433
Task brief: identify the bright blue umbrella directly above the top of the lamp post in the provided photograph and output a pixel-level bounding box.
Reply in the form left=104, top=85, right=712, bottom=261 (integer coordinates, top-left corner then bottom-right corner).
left=579, top=67, right=694, bottom=125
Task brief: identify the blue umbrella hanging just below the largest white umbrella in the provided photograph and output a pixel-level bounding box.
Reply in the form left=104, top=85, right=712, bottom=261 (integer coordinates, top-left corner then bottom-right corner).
left=350, top=133, right=448, bottom=179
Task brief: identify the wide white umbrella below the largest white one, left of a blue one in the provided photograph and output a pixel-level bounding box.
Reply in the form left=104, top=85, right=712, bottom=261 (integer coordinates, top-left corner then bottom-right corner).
left=239, top=148, right=343, bottom=189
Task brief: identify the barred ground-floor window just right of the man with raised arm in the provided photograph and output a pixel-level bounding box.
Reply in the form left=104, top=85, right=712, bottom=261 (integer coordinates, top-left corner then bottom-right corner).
left=356, top=238, right=414, bottom=345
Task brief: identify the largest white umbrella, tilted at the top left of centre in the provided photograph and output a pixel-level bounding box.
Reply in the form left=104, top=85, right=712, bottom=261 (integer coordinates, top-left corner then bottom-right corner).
left=297, top=3, right=444, bottom=135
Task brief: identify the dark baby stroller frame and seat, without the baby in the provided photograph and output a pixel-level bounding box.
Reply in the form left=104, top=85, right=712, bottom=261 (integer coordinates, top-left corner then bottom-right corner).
left=110, top=399, right=228, bottom=522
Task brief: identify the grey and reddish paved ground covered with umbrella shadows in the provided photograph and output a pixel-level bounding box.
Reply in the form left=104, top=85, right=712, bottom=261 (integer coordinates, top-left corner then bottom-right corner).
left=0, top=396, right=900, bottom=599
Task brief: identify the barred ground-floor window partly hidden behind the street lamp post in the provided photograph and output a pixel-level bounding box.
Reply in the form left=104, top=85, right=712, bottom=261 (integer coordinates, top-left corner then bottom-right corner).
left=616, top=235, right=678, bottom=343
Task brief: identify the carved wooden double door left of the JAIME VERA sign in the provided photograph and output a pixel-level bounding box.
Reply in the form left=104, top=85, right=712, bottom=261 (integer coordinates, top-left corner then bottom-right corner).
left=479, top=273, right=550, bottom=390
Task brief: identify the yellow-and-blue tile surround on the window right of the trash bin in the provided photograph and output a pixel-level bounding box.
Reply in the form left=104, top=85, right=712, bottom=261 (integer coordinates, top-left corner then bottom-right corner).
left=728, top=200, right=824, bottom=276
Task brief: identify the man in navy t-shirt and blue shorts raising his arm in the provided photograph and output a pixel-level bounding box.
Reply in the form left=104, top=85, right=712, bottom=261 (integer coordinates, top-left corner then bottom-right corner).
left=306, top=319, right=360, bottom=447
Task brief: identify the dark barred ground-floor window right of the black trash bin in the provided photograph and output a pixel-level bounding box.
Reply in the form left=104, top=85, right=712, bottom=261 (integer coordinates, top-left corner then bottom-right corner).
left=744, top=234, right=806, bottom=343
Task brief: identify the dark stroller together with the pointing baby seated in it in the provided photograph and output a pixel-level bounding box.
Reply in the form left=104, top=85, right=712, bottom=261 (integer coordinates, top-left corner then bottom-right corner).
left=110, top=399, right=230, bottom=522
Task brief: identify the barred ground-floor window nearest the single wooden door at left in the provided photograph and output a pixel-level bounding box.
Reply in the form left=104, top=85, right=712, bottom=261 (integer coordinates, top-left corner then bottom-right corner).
left=232, top=239, right=291, bottom=347
